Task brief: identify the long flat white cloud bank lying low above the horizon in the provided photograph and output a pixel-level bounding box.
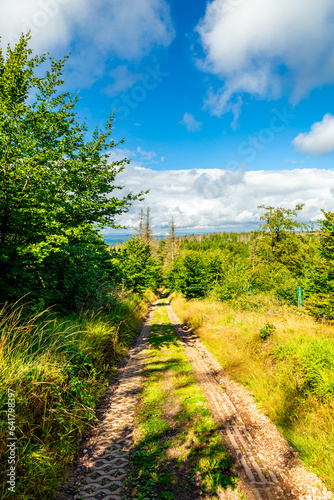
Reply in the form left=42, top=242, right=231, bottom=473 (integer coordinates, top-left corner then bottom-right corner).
left=105, top=153, right=334, bottom=234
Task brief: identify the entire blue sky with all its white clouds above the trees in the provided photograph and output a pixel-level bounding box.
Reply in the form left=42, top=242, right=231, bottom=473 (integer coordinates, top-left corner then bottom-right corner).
left=0, top=0, right=334, bottom=234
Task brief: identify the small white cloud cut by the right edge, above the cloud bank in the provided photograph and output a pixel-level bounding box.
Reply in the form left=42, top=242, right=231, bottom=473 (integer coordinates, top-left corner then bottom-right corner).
left=292, top=113, right=334, bottom=156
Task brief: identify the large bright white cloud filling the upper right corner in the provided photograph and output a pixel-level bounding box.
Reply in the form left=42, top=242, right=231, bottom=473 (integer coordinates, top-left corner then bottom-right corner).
left=197, top=0, right=334, bottom=116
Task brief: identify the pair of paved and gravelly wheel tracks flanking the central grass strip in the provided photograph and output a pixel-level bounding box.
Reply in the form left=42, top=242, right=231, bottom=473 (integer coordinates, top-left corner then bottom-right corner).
left=69, top=304, right=333, bottom=500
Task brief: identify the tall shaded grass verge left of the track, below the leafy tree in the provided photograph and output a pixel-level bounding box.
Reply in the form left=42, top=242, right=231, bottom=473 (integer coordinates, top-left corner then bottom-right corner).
left=0, top=294, right=153, bottom=500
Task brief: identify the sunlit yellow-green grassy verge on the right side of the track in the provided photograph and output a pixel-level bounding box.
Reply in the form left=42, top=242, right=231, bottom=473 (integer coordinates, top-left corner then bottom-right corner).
left=172, top=297, right=334, bottom=490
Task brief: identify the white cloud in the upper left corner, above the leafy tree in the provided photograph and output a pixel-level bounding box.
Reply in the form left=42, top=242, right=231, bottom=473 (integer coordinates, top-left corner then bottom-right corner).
left=0, top=0, right=174, bottom=86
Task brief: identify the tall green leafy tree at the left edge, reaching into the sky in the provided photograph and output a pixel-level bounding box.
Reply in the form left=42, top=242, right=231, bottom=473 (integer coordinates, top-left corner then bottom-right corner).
left=0, top=35, right=143, bottom=302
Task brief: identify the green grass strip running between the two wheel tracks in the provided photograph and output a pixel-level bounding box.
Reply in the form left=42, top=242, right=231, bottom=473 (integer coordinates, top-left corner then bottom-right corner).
left=126, top=307, right=236, bottom=500
